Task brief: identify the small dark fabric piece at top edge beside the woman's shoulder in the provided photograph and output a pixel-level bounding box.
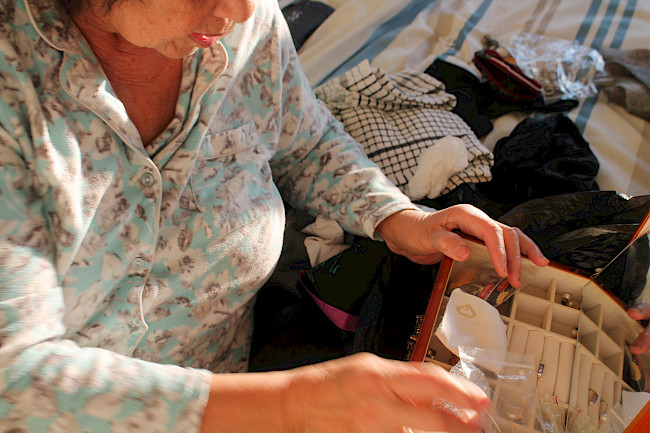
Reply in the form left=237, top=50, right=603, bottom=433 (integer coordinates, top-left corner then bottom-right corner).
left=282, top=0, right=334, bottom=51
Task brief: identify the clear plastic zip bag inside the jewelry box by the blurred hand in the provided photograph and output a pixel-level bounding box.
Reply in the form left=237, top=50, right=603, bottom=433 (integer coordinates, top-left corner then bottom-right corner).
left=451, top=346, right=544, bottom=433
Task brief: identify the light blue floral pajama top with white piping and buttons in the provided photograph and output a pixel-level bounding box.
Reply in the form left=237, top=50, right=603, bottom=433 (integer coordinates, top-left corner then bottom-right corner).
left=0, top=0, right=414, bottom=433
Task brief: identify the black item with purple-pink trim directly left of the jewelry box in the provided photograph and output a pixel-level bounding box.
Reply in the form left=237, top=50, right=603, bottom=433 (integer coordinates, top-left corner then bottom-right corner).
left=299, top=238, right=438, bottom=359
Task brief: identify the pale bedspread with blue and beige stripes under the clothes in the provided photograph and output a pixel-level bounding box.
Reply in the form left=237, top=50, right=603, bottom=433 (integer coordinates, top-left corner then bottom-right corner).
left=294, top=0, right=650, bottom=196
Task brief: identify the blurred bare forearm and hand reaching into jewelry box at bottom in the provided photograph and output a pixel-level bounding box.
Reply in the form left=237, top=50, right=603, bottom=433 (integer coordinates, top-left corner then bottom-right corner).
left=202, top=353, right=490, bottom=433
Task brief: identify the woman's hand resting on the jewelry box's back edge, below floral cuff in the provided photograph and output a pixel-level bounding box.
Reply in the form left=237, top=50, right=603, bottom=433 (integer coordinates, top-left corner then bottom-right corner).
left=376, top=204, right=549, bottom=287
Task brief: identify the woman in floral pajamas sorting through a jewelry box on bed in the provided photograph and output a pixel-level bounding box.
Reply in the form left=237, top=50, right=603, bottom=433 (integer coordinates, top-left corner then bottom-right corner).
left=0, top=0, right=547, bottom=433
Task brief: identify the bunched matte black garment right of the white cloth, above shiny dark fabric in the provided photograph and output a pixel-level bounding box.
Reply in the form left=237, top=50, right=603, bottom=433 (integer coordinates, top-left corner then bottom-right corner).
left=420, top=113, right=600, bottom=218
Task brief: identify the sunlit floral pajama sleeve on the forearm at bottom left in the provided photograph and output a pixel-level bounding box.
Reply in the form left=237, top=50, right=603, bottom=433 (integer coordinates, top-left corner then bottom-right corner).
left=0, top=340, right=209, bottom=433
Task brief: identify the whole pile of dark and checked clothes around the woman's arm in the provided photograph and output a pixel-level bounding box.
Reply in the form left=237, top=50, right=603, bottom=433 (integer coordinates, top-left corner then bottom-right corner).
left=251, top=4, right=650, bottom=370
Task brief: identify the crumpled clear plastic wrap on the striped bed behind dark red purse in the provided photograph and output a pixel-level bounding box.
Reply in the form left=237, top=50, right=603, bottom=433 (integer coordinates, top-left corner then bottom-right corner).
left=502, top=33, right=605, bottom=104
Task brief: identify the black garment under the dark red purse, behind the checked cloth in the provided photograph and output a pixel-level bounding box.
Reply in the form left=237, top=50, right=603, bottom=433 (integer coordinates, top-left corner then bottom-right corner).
left=424, top=59, right=578, bottom=137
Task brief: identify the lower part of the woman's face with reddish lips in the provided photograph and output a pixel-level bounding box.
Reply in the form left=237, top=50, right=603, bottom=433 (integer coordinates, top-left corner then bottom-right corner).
left=88, top=0, right=255, bottom=58
